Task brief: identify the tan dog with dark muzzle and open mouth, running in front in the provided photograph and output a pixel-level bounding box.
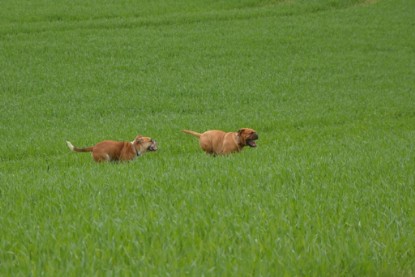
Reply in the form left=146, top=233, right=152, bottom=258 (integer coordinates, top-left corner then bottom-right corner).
left=182, top=128, right=258, bottom=156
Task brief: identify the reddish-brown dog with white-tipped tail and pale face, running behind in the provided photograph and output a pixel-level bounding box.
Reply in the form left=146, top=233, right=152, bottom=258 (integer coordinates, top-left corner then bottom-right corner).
left=66, top=135, right=157, bottom=162
